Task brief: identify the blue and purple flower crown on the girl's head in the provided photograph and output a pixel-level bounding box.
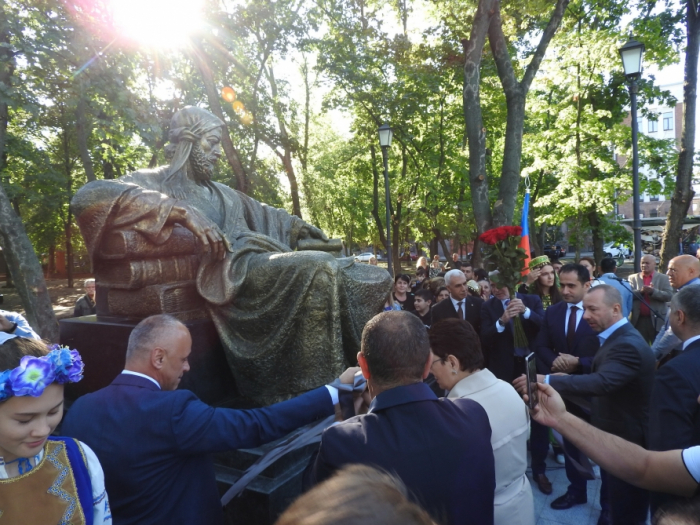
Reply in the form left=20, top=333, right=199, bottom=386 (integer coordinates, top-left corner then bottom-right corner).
left=0, top=345, right=84, bottom=401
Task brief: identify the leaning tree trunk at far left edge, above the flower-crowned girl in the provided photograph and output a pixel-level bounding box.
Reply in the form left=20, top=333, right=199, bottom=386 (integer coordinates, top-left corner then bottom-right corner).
left=0, top=22, right=58, bottom=343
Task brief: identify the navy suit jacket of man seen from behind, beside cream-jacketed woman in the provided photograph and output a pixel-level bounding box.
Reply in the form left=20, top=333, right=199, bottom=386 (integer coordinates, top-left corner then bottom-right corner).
left=304, top=383, right=495, bottom=525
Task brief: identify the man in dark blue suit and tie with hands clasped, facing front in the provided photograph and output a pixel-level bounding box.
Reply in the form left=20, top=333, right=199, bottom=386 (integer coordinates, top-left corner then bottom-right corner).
left=530, top=264, right=600, bottom=504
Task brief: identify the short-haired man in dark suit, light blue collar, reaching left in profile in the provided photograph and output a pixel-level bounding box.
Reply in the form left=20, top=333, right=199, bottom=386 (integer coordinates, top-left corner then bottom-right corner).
left=514, top=284, right=655, bottom=525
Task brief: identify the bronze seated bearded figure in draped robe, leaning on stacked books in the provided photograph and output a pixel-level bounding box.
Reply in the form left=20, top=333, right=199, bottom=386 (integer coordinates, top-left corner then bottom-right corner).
left=71, top=107, right=391, bottom=404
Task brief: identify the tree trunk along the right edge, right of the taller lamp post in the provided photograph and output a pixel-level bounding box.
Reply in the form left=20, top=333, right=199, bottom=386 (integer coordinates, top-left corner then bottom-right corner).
left=660, top=2, right=700, bottom=271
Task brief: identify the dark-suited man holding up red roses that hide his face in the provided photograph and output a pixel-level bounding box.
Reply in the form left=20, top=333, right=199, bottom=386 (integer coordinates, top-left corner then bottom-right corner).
left=481, top=272, right=544, bottom=383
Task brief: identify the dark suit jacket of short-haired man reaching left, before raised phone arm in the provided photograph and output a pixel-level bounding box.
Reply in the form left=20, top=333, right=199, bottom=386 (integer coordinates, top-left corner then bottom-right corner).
left=549, top=323, right=656, bottom=446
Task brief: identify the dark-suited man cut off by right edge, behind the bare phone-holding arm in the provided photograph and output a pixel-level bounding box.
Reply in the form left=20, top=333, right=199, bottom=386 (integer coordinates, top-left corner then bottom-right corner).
left=649, top=286, right=700, bottom=512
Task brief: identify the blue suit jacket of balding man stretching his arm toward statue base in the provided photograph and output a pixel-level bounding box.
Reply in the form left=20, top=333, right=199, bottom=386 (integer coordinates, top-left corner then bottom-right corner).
left=62, top=374, right=333, bottom=525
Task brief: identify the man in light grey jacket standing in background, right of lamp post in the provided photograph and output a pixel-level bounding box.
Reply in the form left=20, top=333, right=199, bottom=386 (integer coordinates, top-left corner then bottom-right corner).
left=629, top=254, right=673, bottom=344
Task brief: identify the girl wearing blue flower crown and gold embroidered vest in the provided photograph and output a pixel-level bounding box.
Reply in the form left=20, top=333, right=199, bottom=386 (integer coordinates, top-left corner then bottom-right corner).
left=0, top=337, right=112, bottom=525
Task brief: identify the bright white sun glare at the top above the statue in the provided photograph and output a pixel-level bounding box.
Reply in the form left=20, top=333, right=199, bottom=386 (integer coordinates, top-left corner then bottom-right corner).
left=110, top=0, right=203, bottom=48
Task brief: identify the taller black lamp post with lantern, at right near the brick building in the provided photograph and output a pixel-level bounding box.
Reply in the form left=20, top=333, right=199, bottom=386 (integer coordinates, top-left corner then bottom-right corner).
left=620, top=39, right=644, bottom=273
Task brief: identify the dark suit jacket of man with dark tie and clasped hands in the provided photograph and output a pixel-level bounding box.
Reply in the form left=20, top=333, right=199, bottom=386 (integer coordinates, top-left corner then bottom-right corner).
left=532, top=301, right=600, bottom=374
